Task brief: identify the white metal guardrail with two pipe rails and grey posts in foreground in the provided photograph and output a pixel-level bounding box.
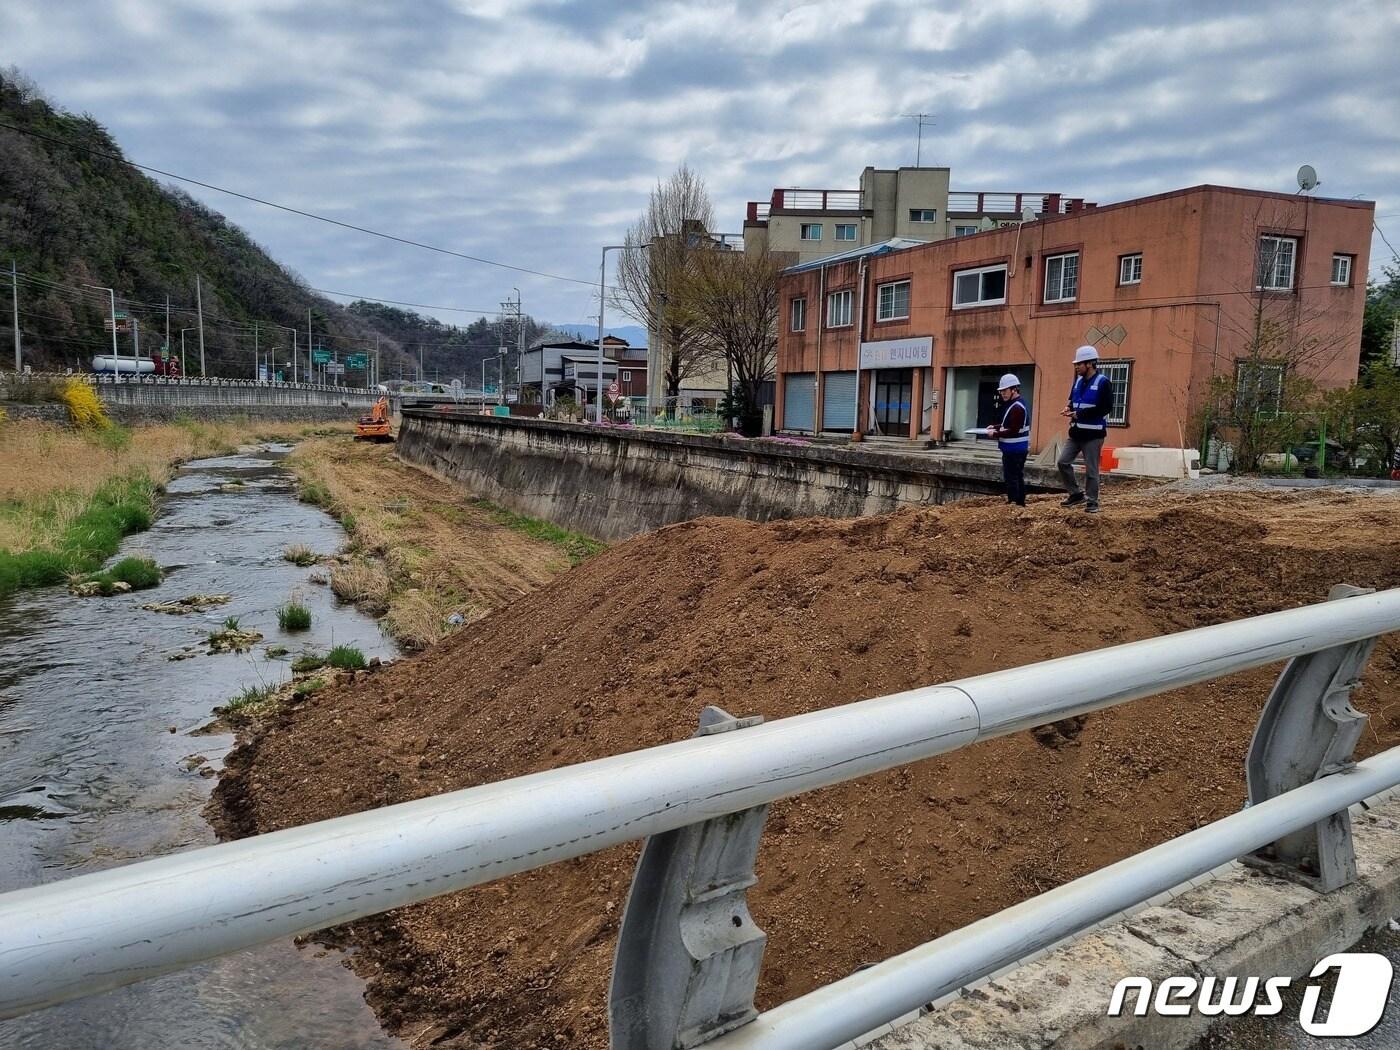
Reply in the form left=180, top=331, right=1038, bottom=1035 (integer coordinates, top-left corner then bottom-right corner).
left=0, top=587, right=1400, bottom=1050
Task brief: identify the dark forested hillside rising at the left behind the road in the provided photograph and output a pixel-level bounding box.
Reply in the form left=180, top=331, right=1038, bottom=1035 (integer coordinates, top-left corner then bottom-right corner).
left=0, top=69, right=542, bottom=381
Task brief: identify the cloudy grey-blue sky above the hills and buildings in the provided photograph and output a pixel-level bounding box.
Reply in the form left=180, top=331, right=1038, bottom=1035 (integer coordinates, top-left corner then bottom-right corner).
left=0, top=0, right=1400, bottom=329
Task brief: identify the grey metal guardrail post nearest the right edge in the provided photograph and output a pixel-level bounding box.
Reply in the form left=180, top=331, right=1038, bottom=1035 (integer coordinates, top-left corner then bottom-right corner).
left=1243, top=584, right=1376, bottom=893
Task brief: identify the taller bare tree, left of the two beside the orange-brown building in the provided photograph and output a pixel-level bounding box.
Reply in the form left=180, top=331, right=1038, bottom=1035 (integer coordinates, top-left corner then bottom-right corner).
left=615, top=164, right=714, bottom=398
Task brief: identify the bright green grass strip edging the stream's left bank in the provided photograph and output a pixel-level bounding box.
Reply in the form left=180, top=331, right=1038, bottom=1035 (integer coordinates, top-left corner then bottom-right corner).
left=0, top=473, right=160, bottom=595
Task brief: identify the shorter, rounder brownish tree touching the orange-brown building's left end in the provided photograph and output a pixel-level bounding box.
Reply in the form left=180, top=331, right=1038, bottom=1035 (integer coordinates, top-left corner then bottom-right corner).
left=682, top=248, right=783, bottom=435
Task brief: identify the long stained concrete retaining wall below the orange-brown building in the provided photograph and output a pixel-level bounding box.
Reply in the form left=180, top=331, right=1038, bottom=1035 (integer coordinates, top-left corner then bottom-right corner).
left=398, top=409, right=1053, bottom=540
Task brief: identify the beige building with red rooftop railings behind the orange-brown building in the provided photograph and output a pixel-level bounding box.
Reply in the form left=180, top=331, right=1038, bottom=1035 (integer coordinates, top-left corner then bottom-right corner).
left=743, top=168, right=1085, bottom=266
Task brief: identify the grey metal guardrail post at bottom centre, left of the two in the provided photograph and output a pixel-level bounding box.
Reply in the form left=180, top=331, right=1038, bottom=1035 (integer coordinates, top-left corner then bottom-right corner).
left=608, top=707, right=769, bottom=1050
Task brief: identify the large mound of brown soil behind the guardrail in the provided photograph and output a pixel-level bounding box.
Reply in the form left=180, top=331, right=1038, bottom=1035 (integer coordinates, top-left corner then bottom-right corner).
left=207, top=493, right=1400, bottom=1049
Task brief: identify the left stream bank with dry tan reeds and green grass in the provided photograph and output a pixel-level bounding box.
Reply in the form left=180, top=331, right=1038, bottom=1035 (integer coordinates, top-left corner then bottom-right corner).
left=0, top=420, right=350, bottom=595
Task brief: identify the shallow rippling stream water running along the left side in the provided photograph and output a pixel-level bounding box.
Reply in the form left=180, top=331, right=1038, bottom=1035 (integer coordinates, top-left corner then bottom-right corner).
left=0, top=445, right=403, bottom=1050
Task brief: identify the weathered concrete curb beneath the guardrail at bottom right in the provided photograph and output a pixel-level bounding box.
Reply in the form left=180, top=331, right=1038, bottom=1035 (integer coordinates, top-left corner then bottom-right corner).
left=850, top=791, right=1400, bottom=1050
